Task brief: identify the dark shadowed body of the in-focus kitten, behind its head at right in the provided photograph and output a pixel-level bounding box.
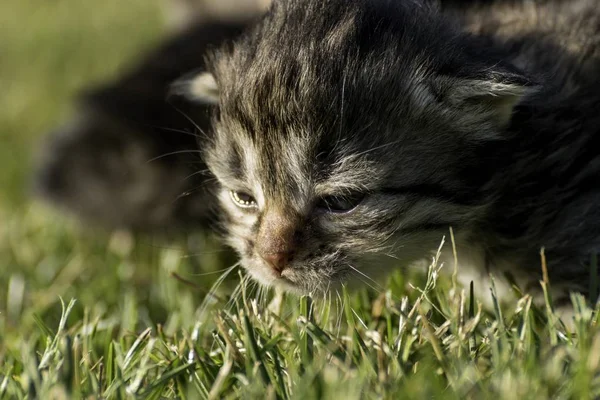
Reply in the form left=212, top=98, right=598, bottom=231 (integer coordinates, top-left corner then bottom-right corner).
left=454, top=0, right=600, bottom=300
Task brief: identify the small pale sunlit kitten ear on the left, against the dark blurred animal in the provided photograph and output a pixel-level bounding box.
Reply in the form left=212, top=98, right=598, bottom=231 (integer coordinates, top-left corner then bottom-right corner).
left=169, top=72, right=219, bottom=105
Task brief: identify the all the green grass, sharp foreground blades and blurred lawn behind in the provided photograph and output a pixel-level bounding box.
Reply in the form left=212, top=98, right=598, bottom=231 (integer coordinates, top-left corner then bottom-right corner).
left=0, top=0, right=600, bottom=399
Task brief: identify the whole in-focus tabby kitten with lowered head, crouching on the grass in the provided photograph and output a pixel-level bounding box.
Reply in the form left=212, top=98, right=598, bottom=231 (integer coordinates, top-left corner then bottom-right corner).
left=177, top=0, right=600, bottom=302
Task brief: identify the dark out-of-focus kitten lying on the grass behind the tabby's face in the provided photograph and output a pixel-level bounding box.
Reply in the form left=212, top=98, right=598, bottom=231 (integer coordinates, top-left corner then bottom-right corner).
left=34, top=4, right=258, bottom=230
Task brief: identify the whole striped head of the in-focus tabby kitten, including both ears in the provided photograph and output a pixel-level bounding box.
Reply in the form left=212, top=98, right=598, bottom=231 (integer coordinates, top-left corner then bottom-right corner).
left=178, top=0, right=529, bottom=292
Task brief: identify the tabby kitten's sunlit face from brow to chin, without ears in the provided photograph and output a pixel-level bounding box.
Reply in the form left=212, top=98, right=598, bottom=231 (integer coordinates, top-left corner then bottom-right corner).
left=205, top=120, right=450, bottom=293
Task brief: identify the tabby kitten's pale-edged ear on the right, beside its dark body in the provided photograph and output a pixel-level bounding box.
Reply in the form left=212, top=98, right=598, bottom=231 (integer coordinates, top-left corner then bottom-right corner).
left=433, top=71, right=537, bottom=127
